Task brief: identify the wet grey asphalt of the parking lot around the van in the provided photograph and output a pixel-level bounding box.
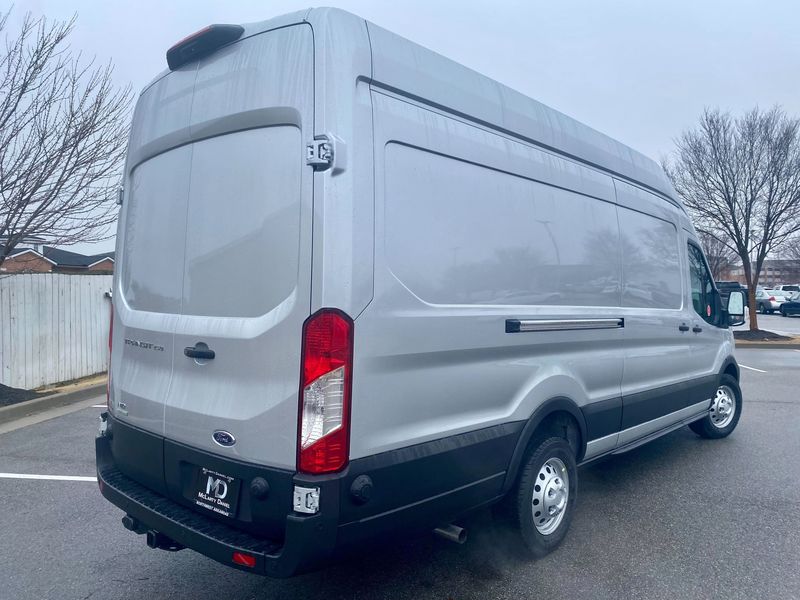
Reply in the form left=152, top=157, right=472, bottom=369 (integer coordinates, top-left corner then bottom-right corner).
left=0, top=346, right=800, bottom=600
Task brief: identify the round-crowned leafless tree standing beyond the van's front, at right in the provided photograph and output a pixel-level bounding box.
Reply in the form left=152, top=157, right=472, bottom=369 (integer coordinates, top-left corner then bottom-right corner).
left=664, top=107, right=800, bottom=330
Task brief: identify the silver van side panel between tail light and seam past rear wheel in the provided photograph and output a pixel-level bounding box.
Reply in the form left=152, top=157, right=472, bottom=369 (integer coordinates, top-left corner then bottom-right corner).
left=351, top=91, right=624, bottom=464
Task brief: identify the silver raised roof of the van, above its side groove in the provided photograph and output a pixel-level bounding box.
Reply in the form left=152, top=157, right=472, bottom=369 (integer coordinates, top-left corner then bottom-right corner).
left=152, top=8, right=685, bottom=206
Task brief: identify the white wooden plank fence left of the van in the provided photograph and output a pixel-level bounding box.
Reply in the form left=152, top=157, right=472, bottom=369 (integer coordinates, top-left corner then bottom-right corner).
left=0, top=273, right=111, bottom=389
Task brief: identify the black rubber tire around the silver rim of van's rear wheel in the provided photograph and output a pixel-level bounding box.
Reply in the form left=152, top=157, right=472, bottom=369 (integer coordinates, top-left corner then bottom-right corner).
left=508, top=437, right=578, bottom=558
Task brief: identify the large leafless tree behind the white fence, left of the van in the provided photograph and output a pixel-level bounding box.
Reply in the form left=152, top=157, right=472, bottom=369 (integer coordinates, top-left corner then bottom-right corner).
left=0, top=8, right=132, bottom=265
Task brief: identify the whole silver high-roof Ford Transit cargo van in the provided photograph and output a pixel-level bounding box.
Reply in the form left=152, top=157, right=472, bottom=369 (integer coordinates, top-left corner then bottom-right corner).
left=96, top=9, right=744, bottom=577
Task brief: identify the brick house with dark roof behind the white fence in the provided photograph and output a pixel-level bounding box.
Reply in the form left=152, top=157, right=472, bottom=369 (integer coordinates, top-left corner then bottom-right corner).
left=0, top=244, right=114, bottom=275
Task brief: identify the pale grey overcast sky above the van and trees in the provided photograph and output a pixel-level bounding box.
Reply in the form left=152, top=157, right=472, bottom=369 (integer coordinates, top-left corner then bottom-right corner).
left=7, top=0, right=800, bottom=252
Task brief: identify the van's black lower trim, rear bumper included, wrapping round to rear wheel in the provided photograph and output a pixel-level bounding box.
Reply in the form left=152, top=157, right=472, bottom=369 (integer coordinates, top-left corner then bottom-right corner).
left=95, top=416, right=523, bottom=577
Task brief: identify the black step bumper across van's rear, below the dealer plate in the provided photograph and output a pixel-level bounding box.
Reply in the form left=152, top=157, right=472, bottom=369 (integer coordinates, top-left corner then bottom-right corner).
left=95, top=436, right=338, bottom=577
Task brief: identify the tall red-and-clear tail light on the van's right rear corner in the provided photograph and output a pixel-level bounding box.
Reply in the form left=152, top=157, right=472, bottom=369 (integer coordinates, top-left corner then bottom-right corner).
left=297, top=309, right=353, bottom=474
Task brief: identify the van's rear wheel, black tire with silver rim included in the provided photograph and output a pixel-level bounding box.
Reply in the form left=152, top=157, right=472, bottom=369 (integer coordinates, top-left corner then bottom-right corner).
left=509, top=437, right=578, bottom=558
